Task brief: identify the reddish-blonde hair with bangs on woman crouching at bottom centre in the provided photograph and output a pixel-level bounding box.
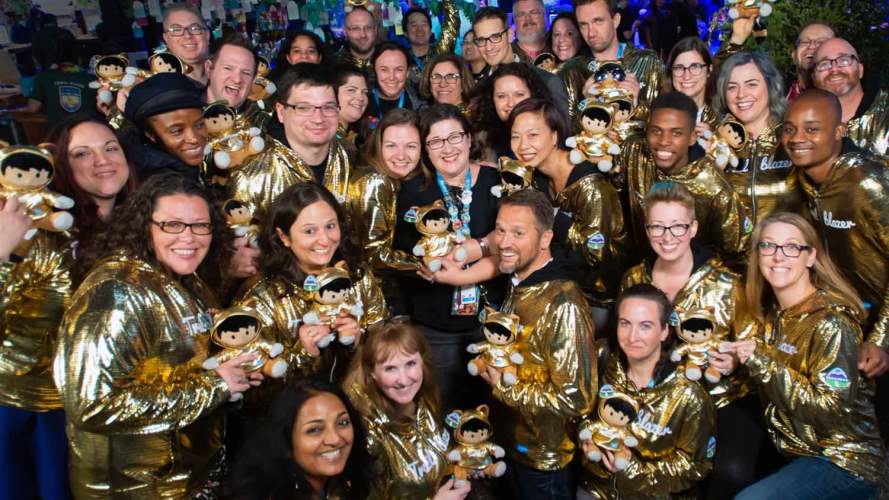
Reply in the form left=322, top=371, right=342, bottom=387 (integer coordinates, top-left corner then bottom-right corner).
left=343, top=317, right=441, bottom=422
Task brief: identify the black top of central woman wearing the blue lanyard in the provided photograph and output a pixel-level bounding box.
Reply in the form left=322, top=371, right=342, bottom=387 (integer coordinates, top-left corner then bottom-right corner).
left=394, top=167, right=506, bottom=332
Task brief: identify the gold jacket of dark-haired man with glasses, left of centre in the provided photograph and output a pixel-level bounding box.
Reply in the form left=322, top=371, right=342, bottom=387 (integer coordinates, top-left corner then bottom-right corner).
left=226, top=138, right=350, bottom=221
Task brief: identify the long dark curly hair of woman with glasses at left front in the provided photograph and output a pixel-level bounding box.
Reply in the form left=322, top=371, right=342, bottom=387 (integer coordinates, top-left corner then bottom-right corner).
left=81, top=172, right=234, bottom=287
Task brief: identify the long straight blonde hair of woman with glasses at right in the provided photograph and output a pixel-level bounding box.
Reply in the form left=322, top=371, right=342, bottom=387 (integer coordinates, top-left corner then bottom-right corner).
left=745, top=212, right=867, bottom=322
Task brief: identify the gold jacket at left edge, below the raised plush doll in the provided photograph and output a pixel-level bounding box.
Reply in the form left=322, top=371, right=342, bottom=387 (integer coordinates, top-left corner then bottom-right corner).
left=0, top=231, right=71, bottom=411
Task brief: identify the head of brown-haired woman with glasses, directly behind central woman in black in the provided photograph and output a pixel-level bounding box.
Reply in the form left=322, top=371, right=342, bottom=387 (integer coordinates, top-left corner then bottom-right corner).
left=420, top=54, right=475, bottom=111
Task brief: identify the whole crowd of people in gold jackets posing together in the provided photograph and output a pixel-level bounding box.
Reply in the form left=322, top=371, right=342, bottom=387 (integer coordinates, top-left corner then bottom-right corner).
left=0, top=0, right=889, bottom=500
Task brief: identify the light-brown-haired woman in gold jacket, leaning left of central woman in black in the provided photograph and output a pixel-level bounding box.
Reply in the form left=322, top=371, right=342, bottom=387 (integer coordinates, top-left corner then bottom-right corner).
left=345, top=109, right=423, bottom=314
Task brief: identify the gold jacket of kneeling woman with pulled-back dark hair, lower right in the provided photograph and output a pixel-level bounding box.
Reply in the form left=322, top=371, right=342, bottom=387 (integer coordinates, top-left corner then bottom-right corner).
left=581, top=353, right=718, bottom=499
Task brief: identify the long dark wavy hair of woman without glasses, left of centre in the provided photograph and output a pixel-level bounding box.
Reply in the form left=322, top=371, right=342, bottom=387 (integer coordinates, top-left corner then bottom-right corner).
left=259, top=182, right=363, bottom=287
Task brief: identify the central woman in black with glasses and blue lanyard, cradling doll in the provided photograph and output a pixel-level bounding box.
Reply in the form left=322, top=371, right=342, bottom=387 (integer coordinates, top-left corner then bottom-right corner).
left=395, top=104, right=504, bottom=412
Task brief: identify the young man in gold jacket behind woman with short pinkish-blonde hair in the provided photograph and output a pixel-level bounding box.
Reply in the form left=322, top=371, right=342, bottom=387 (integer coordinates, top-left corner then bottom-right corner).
left=615, top=92, right=753, bottom=266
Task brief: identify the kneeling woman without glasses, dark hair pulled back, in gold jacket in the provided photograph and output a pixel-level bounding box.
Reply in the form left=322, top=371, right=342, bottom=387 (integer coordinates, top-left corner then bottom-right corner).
left=577, top=283, right=719, bottom=500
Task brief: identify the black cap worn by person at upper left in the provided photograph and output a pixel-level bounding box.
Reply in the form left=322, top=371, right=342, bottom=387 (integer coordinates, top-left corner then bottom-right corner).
left=123, top=73, right=204, bottom=124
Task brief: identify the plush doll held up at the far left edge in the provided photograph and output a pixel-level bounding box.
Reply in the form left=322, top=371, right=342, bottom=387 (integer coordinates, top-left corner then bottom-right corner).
left=0, top=141, right=74, bottom=256
